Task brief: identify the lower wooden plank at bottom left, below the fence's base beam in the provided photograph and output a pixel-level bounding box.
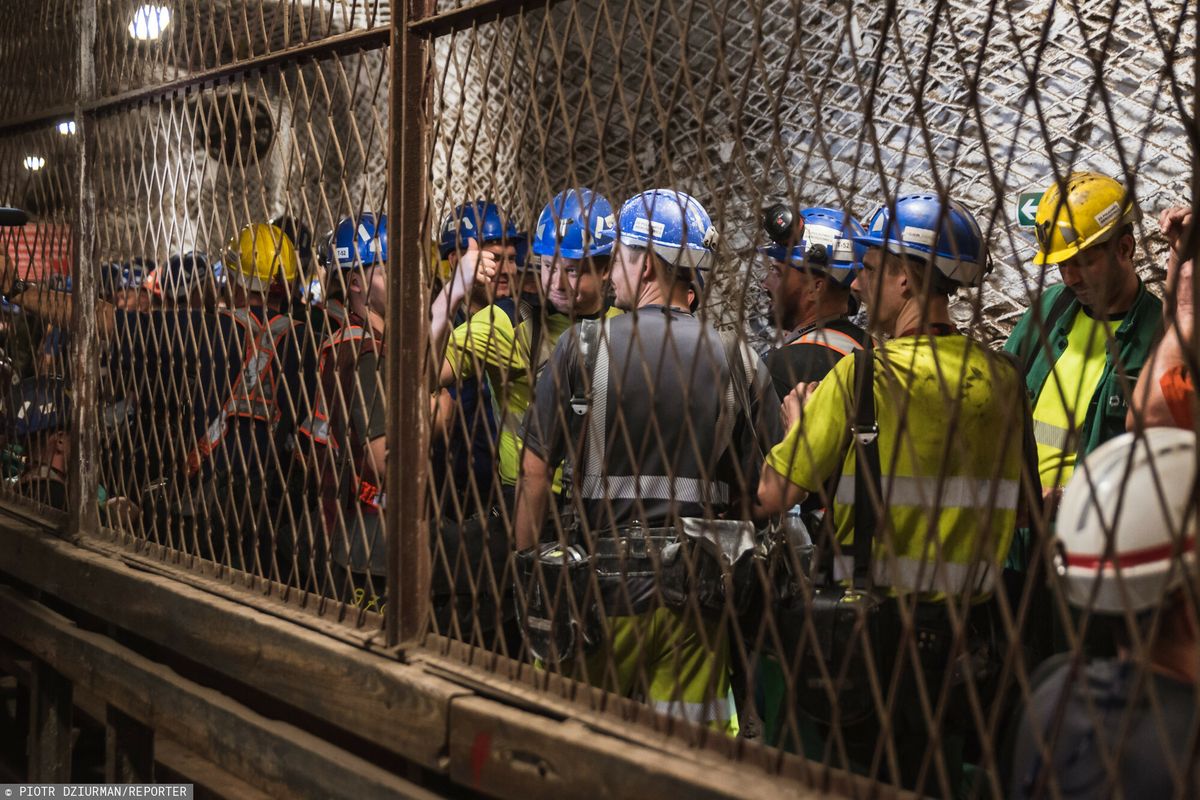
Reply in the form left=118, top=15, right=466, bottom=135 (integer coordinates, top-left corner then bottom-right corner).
left=0, top=588, right=436, bottom=800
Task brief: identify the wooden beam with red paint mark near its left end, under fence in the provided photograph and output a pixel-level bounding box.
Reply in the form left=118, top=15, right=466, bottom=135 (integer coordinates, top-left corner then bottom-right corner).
left=450, top=698, right=824, bottom=800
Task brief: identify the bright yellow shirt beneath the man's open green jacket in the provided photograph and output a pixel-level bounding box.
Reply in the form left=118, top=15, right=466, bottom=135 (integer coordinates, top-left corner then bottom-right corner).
left=1033, top=312, right=1121, bottom=487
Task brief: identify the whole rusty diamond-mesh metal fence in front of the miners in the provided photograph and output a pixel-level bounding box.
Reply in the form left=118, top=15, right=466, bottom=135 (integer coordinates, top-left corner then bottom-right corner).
left=0, top=0, right=1200, bottom=796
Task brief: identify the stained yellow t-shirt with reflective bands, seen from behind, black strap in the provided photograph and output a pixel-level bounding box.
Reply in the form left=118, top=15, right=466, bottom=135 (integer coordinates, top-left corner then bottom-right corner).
left=767, top=335, right=1028, bottom=602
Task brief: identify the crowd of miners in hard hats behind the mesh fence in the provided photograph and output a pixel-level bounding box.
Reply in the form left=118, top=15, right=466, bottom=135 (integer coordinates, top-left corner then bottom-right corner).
left=2, top=172, right=1200, bottom=796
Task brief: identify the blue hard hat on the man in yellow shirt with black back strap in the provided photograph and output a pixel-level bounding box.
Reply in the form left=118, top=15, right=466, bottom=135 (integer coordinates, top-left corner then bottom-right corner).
left=854, top=194, right=991, bottom=287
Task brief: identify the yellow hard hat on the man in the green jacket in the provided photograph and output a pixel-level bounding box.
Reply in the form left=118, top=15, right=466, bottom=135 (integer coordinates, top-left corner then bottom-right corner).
left=1033, top=173, right=1141, bottom=264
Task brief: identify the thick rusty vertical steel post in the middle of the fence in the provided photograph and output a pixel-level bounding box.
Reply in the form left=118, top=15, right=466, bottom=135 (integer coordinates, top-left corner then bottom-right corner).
left=386, top=0, right=433, bottom=645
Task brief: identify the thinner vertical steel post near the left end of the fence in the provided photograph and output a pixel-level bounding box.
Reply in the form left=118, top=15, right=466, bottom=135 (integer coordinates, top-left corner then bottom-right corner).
left=67, top=0, right=100, bottom=539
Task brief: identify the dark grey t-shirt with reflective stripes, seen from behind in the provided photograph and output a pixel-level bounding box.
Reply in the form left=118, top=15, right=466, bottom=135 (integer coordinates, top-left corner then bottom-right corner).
left=521, top=306, right=781, bottom=530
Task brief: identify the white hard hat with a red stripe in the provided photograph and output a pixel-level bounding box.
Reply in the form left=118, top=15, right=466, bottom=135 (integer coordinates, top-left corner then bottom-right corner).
left=1056, top=428, right=1196, bottom=614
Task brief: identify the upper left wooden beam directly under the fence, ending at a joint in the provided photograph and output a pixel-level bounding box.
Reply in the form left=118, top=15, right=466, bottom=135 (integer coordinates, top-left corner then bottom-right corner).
left=0, top=529, right=469, bottom=771
